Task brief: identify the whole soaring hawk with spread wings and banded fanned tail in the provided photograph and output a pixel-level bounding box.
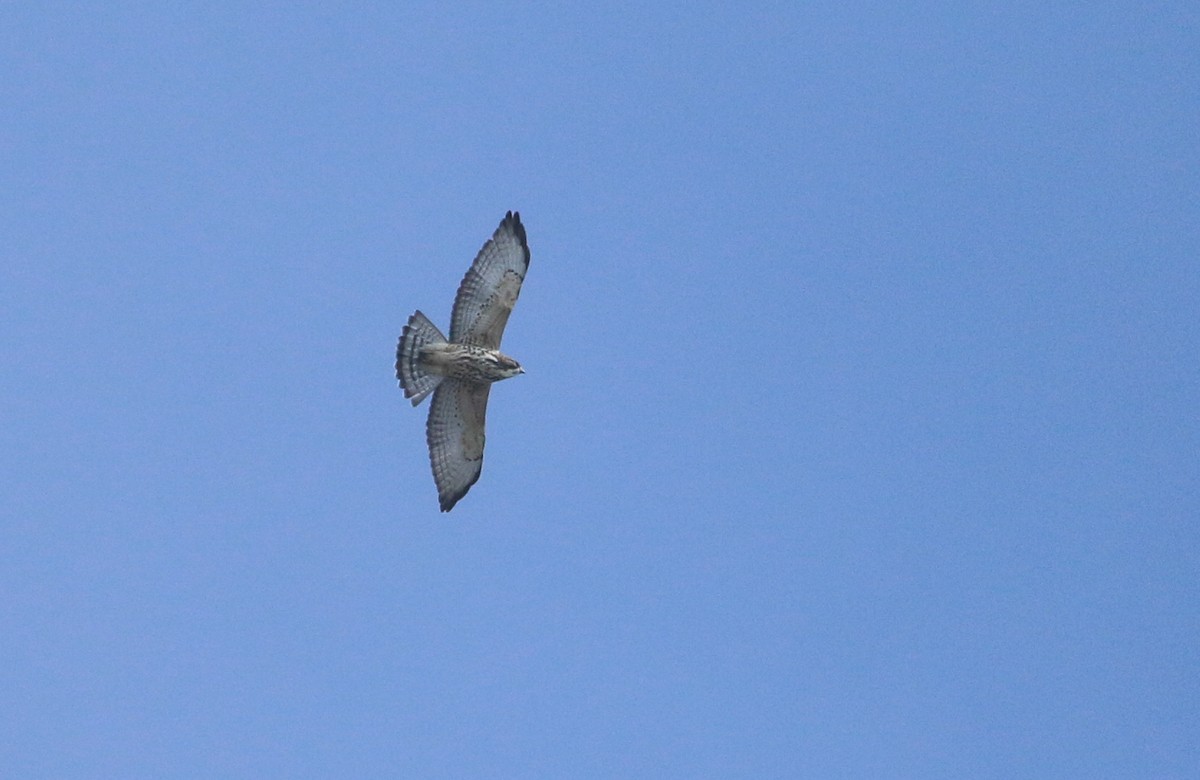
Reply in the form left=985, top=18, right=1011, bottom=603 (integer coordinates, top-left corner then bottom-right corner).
left=396, top=211, right=529, bottom=512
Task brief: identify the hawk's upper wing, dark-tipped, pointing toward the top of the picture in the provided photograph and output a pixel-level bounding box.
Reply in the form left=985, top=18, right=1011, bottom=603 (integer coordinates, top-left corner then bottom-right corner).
left=450, top=211, right=529, bottom=349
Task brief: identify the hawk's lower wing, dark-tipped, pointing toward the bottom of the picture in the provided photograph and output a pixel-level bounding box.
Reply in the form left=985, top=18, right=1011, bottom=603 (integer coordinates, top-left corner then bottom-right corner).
left=425, top=378, right=492, bottom=512
